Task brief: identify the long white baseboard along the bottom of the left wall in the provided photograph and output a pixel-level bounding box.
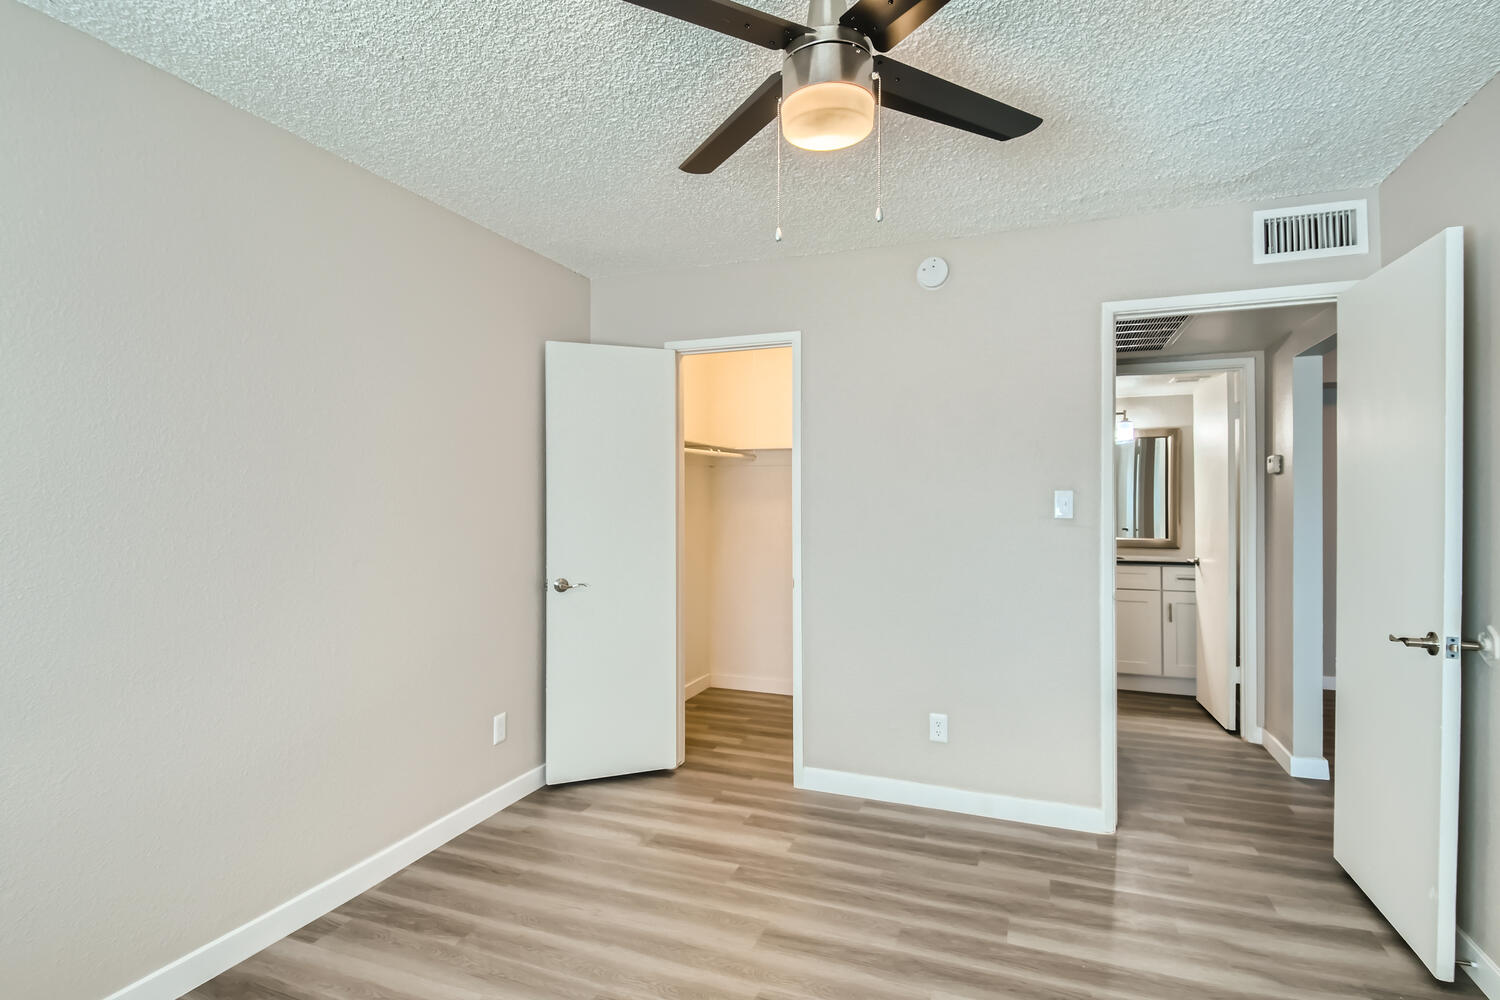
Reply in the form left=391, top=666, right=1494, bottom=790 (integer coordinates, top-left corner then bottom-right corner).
left=107, top=768, right=543, bottom=1000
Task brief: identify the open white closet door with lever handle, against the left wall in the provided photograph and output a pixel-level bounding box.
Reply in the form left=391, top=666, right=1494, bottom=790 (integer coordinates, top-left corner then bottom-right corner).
left=546, top=342, right=681, bottom=784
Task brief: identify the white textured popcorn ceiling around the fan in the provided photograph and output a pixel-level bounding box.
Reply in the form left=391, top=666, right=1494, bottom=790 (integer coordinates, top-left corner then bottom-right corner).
left=26, top=0, right=1500, bottom=276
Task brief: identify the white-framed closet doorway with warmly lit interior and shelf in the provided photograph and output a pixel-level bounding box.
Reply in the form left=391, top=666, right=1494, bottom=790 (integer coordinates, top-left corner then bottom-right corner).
left=666, top=333, right=803, bottom=784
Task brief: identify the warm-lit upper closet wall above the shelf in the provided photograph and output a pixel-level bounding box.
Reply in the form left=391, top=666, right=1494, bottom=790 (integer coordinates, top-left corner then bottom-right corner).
left=681, top=348, right=792, bottom=448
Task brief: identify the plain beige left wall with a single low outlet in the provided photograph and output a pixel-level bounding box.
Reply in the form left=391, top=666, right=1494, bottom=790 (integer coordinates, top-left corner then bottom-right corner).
left=0, top=3, right=588, bottom=1000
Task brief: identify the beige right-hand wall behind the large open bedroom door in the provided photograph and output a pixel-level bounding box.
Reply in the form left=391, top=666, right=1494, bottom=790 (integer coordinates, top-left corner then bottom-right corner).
left=1380, top=78, right=1500, bottom=977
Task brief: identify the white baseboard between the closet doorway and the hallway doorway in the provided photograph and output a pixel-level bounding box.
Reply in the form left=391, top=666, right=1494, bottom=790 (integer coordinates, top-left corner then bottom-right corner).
left=797, top=768, right=1115, bottom=834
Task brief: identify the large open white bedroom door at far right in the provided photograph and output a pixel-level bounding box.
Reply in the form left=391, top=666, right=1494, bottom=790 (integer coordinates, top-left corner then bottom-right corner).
left=1334, top=228, right=1464, bottom=982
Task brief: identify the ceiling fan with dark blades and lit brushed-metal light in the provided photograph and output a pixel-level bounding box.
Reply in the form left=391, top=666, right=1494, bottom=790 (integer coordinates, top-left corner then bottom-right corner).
left=627, top=0, right=1041, bottom=174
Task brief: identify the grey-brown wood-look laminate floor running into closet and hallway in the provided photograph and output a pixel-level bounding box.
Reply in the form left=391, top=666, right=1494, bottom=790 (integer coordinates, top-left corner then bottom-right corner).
left=189, top=690, right=1481, bottom=1000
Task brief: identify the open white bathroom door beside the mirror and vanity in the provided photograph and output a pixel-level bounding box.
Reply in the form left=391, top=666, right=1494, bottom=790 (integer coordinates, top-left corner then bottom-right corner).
left=1193, top=375, right=1239, bottom=730
